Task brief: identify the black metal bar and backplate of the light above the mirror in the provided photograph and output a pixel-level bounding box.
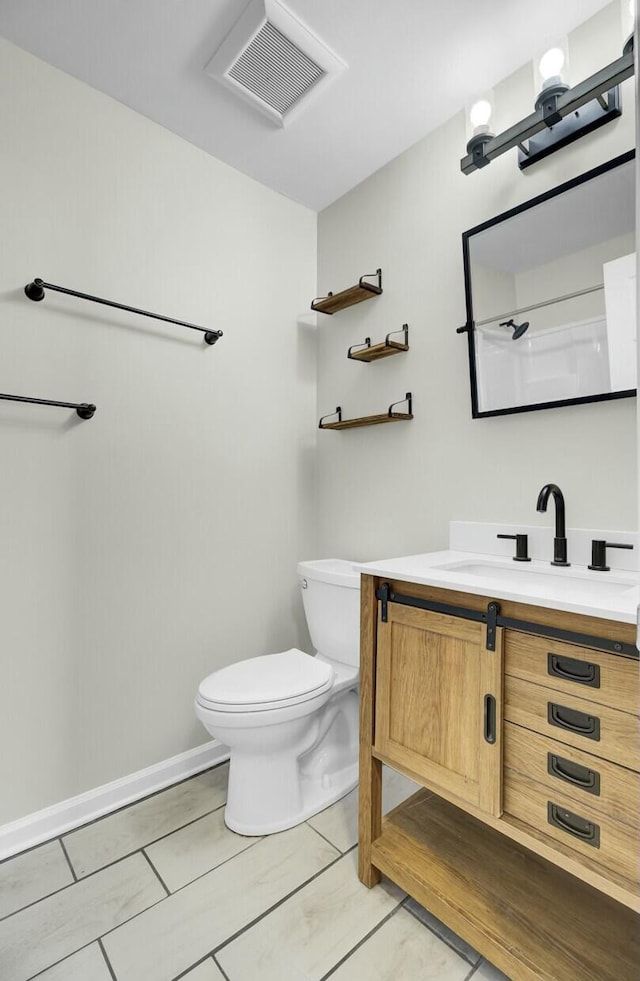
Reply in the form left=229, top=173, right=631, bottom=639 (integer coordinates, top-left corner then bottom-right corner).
left=460, top=50, right=635, bottom=174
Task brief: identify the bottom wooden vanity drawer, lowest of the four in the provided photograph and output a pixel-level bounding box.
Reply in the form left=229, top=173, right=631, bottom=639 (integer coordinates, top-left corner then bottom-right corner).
left=503, top=770, right=640, bottom=883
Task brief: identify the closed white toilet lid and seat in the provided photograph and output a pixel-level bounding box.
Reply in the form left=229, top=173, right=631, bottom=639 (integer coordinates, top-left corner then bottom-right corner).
left=198, top=647, right=334, bottom=711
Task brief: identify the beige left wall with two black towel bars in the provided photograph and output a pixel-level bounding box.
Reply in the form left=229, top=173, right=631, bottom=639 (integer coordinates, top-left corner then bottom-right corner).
left=0, top=42, right=316, bottom=824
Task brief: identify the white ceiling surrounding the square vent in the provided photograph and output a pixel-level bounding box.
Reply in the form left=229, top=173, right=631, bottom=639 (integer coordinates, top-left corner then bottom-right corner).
left=0, top=0, right=609, bottom=210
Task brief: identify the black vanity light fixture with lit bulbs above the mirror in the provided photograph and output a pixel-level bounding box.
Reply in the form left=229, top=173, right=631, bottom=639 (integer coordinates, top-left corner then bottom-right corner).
left=460, top=32, right=634, bottom=174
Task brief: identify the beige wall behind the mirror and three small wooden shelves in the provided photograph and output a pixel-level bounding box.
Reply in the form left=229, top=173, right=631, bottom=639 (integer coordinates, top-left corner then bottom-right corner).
left=318, top=4, right=638, bottom=564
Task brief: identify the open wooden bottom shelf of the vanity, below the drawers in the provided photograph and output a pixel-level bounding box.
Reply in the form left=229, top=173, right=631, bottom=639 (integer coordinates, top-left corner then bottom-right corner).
left=372, top=790, right=640, bottom=981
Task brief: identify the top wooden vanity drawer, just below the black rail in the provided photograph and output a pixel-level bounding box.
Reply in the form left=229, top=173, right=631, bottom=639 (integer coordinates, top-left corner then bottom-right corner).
left=504, top=630, right=640, bottom=714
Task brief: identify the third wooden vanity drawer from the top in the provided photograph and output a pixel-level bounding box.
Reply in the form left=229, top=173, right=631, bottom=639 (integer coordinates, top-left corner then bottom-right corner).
left=503, top=722, right=640, bottom=836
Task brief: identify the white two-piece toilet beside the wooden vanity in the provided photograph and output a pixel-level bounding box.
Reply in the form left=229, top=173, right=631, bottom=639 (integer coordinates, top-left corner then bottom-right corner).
left=195, top=559, right=360, bottom=835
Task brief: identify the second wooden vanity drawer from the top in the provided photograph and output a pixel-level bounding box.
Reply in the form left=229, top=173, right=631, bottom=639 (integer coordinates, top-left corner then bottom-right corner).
left=504, top=675, right=640, bottom=770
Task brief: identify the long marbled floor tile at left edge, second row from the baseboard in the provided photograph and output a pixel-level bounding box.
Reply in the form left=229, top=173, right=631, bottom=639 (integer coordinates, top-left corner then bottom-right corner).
left=0, top=854, right=166, bottom=981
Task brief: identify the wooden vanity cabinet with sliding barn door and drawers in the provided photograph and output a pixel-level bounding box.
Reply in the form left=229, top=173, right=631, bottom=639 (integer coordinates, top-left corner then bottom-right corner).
left=359, top=576, right=640, bottom=981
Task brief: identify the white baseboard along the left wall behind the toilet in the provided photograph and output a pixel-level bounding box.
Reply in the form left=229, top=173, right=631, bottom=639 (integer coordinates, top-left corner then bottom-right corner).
left=0, top=739, right=229, bottom=860
